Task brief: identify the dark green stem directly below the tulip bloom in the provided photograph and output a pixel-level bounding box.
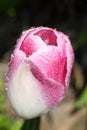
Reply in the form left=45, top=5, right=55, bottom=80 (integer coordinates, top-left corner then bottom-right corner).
left=21, top=117, right=40, bottom=130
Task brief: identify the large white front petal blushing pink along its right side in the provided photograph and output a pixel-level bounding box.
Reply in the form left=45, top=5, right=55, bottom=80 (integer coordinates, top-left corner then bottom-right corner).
left=7, top=62, right=65, bottom=119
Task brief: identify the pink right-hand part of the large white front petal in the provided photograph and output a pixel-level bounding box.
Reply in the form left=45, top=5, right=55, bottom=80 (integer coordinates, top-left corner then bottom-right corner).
left=29, top=61, right=65, bottom=110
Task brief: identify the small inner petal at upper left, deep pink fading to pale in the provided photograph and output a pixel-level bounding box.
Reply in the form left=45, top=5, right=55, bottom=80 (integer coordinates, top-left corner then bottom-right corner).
left=20, top=34, right=46, bottom=57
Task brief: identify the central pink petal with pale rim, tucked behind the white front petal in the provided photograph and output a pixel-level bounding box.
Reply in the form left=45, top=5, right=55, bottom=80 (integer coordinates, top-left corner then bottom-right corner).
left=28, top=46, right=67, bottom=85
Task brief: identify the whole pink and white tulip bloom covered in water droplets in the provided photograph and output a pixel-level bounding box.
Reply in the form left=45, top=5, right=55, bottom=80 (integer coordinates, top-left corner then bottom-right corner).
left=6, top=27, right=74, bottom=119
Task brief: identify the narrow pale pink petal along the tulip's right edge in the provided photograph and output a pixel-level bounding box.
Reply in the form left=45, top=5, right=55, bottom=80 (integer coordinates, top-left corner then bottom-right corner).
left=57, top=32, right=74, bottom=87
